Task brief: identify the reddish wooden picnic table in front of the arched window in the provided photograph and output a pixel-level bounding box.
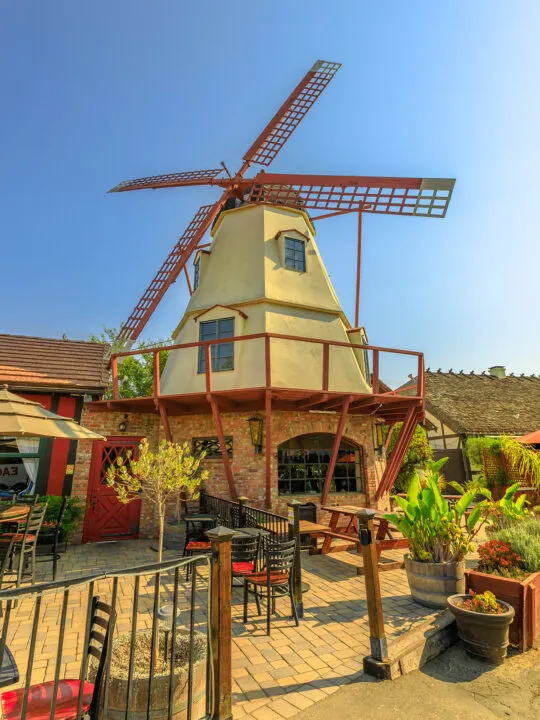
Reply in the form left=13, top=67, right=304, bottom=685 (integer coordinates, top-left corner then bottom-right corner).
left=320, top=505, right=409, bottom=575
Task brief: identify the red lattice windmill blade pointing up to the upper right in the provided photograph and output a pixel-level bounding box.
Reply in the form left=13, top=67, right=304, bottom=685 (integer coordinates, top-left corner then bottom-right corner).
left=244, top=60, right=341, bottom=170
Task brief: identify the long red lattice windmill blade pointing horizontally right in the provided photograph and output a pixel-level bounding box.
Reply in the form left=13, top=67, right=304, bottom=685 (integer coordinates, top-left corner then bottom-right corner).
left=248, top=173, right=455, bottom=218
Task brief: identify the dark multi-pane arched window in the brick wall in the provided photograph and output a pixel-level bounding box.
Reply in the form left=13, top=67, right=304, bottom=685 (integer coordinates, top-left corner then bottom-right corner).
left=278, top=433, right=365, bottom=496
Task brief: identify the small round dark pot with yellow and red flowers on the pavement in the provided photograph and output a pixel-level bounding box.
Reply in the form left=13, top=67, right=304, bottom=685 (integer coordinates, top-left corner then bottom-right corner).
left=448, top=590, right=515, bottom=665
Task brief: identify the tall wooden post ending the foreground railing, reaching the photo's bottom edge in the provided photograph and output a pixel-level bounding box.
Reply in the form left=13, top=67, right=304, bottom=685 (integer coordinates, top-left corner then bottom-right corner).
left=206, top=525, right=234, bottom=720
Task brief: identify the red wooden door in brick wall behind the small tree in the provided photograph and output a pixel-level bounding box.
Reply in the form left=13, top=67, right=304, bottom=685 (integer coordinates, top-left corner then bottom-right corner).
left=83, top=437, right=141, bottom=542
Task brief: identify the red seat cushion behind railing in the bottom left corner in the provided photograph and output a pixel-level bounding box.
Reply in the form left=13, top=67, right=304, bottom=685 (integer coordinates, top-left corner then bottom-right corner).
left=2, top=680, right=94, bottom=720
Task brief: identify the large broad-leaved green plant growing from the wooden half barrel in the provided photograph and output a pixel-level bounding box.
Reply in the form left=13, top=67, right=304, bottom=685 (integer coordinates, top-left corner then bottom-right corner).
left=385, top=458, right=485, bottom=563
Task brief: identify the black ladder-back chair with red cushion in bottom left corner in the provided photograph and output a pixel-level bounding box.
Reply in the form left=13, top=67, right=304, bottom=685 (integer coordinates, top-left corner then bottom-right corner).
left=0, top=597, right=113, bottom=720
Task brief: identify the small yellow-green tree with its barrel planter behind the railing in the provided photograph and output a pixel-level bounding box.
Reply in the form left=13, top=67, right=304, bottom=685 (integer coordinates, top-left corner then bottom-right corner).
left=104, top=438, right=208, bottom=720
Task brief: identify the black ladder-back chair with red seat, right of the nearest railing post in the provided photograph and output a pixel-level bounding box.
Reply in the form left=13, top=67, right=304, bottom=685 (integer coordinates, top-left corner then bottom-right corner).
left=244, top=540, right=299, bottom=635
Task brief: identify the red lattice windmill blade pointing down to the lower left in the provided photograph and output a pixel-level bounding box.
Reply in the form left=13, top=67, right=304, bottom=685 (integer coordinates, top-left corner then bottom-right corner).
left=119, top=198, right=224, bottom=343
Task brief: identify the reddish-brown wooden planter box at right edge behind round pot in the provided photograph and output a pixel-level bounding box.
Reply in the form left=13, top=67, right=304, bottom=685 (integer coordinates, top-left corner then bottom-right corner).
left=465, top=570, right=540, bottom=652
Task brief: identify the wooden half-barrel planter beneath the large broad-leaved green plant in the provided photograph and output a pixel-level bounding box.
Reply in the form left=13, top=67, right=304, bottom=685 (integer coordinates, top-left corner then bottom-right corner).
left=404, top=554, right=465, bottom=608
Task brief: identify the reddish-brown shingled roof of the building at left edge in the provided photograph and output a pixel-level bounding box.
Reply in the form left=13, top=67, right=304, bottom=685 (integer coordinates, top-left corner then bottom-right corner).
left=0, top=335, right=109, bottom=395
